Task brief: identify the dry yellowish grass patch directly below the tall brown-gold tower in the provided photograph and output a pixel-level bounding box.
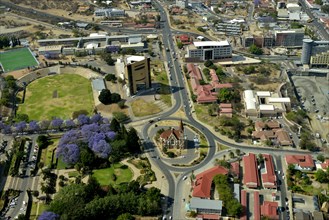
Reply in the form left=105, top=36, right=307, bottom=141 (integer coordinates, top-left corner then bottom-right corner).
left=131, top=98, right=161, bottom=117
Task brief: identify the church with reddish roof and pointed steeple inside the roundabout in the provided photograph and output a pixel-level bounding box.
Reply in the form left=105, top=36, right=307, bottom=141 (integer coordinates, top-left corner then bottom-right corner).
left=160, top=120, right=187, bottom=149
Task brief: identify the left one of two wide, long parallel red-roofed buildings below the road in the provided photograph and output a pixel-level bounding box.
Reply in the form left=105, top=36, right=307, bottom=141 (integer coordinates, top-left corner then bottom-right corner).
left=243, top=153, right=259, bottom=188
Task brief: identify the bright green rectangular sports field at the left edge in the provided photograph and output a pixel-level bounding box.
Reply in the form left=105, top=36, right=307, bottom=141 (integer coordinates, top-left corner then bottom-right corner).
left=0, top=48, right=39, bottom=72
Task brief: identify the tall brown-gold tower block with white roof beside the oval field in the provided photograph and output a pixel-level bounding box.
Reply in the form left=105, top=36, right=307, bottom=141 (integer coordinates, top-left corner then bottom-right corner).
left=125, top=56, right=152, bottom=95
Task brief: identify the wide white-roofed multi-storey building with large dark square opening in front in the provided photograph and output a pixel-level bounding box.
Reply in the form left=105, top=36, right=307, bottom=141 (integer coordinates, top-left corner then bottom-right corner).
left=185, top=40, right=232, bottom=62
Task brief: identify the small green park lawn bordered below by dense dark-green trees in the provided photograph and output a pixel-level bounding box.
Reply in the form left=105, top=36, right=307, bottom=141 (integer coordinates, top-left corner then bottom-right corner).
left=93, top=163, right=133, bottom=186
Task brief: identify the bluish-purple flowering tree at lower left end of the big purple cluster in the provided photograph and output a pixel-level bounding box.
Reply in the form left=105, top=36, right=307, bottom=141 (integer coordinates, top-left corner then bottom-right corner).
left=56, top=144, right=80, bottom=164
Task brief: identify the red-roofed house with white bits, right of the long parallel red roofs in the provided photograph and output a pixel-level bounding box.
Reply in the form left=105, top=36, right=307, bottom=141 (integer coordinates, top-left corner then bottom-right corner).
left=286, top=154, right=315, bottom=171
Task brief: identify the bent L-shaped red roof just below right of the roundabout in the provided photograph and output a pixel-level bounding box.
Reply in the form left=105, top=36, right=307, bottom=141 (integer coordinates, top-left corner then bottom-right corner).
left=192, top=166, right=228, bottom=198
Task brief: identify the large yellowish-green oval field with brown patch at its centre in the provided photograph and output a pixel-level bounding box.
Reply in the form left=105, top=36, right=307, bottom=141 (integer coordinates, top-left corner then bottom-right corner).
left=18, top=74, right=94, bottom=121
